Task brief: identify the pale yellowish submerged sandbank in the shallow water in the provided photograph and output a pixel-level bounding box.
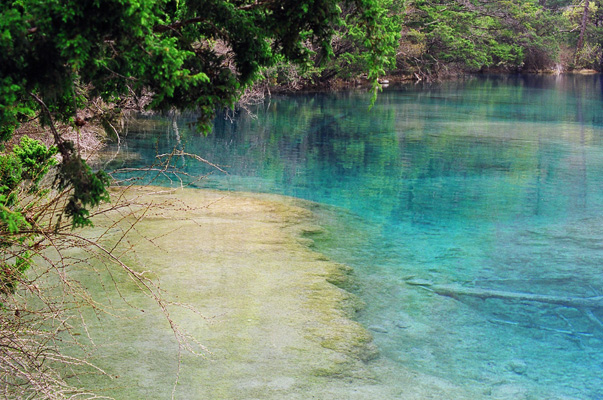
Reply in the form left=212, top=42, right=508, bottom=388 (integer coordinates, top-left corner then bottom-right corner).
left=65, top=188, right=482, bottom=399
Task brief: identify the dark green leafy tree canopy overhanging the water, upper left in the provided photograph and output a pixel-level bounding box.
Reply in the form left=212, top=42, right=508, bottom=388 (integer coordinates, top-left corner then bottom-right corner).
left=0, top=0, right=394, bottom=138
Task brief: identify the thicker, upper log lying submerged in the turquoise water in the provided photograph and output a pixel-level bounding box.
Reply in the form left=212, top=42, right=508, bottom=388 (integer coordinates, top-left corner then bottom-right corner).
left=406, top=279, right=603, bottom=310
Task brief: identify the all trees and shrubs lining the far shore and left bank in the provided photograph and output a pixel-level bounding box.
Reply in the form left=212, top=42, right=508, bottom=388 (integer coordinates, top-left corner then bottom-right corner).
left=0, top=0, right=603, bottom=398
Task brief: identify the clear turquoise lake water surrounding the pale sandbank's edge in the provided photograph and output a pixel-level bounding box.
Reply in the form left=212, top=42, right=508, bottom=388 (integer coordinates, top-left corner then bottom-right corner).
left=104, top=75, right=603, bottom=399
